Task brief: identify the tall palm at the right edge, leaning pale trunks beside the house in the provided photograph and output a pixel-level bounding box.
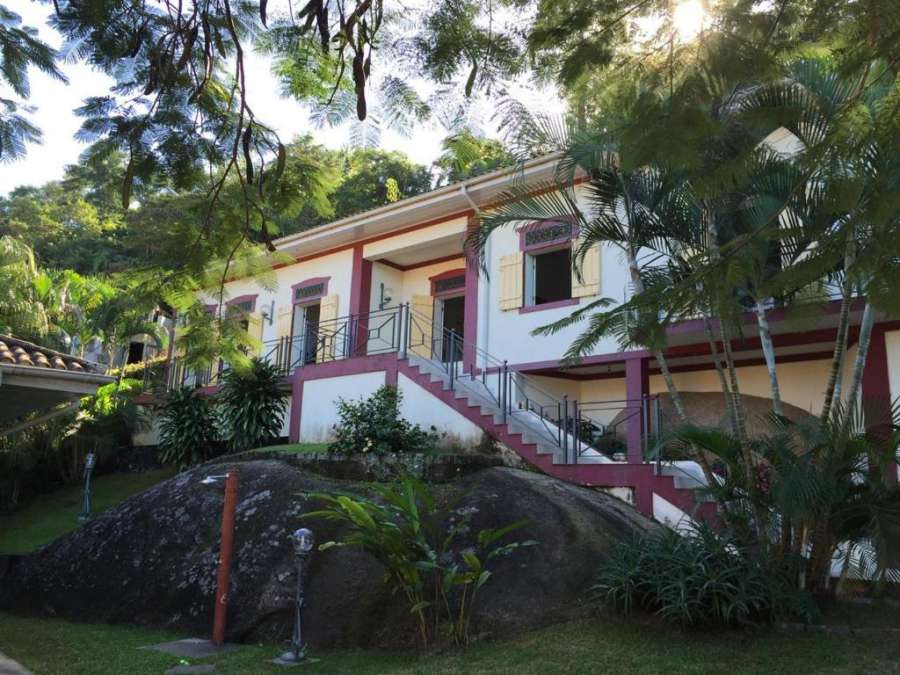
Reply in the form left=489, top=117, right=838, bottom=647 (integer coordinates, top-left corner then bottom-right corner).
left=735, top=58, right=900, bottom=428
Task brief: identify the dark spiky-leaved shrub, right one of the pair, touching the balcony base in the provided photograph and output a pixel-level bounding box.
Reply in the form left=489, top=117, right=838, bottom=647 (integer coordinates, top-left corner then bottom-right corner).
left=218, top=359, right=287, bottom=451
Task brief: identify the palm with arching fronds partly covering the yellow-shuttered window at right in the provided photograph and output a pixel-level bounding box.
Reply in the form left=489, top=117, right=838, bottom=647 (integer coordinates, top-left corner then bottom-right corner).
left=470, top=137, right=728, bottom=485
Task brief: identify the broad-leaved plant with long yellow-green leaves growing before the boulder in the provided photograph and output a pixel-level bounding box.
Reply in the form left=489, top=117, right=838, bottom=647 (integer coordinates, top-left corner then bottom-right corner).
left=304, top=478, right=537, bottom=647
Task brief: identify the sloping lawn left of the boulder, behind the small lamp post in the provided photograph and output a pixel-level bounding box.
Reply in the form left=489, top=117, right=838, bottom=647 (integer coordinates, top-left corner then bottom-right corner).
left=0, top=468, right=175, bottom=553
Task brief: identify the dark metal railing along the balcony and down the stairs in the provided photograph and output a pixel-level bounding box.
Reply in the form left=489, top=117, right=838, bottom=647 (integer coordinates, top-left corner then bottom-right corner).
left=170, top=304, right=663, bottom=464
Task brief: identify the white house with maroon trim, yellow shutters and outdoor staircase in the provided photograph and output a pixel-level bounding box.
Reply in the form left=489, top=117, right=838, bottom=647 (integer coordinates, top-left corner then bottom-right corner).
left=181, top=157, right=900, bottom=519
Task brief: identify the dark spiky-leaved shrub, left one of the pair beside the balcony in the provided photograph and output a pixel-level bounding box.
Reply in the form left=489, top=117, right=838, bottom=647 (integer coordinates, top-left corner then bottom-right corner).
left=160, top=387, right=218, bottom=466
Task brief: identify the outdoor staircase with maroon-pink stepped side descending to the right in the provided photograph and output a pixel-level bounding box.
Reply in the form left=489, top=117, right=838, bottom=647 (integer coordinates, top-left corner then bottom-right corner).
left=398, top=354, right=715, bottom=520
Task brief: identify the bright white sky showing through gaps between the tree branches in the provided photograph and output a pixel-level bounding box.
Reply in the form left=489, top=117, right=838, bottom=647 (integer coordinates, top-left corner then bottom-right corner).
left=0, top=3, right=563, bottom=195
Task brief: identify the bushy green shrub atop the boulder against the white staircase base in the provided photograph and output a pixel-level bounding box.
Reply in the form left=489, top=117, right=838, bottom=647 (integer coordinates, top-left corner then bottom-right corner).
left=328, top=385, right=440, bottom=455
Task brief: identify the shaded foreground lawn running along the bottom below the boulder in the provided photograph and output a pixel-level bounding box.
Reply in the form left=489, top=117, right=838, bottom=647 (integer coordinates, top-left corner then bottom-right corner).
left=0, top=614, right=900, bottom=675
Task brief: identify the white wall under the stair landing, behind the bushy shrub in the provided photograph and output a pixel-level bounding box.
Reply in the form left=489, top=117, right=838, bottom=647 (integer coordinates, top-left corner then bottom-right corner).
left=300, top=370, right=385, bottom=443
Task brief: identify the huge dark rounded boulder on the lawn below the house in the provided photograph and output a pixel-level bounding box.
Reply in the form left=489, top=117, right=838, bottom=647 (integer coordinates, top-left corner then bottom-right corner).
left=0, top=459, right=656, bottom=646
